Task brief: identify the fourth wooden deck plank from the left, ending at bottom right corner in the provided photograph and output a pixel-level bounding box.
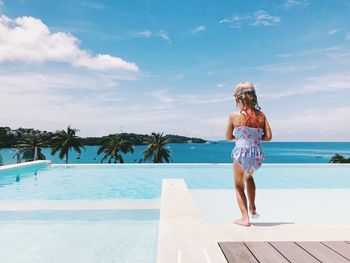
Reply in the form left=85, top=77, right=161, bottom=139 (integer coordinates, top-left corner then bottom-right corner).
left=296, top=242, right=349, bottom=263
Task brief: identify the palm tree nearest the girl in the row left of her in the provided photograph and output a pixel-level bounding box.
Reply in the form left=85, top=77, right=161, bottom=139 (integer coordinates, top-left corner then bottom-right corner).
left=142, top=132, right=171, bottom=163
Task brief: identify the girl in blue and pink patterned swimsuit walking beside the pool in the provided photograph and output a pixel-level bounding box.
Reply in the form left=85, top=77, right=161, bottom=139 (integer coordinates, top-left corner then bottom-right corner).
left=226, top=82, right=272, bottom=226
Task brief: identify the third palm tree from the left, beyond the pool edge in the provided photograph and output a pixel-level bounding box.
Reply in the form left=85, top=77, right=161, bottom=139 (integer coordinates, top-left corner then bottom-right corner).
left=97, top=134, right=134, bottom=163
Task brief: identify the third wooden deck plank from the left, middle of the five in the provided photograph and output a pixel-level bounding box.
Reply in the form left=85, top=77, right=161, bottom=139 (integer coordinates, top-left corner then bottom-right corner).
left=269, top=241, right=320, bottom=263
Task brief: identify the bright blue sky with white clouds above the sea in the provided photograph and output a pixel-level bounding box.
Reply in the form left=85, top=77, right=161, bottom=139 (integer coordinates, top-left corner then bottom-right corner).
left=0, top=0, right=350, bottom=141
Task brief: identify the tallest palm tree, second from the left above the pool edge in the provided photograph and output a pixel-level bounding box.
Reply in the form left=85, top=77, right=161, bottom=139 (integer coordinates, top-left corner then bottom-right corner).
left=51, top=125, right=85, bottom=164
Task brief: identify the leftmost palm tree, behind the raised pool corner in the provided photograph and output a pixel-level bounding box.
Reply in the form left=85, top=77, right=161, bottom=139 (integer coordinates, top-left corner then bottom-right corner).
left=15, top=134, right=46, bottom=162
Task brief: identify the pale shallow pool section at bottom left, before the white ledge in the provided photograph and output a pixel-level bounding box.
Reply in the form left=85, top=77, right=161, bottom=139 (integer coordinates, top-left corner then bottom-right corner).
left=0, top=209, right=159, bottom=263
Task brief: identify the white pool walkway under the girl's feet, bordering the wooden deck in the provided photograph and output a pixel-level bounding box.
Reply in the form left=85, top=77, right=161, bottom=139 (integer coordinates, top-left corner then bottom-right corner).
left=157, top=179, right=350, bottom=263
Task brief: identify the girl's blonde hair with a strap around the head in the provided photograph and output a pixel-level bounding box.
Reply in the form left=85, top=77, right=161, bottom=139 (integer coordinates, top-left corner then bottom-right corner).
left=233, top=82, right=261, bottom=112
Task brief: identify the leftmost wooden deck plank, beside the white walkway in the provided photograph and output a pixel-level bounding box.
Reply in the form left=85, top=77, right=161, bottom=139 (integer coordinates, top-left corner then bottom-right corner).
left=218, top=242, right=258, bottom=263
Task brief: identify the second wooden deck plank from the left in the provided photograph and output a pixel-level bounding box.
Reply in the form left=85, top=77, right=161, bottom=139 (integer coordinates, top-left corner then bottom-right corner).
left=245, top=242, right=288, bottom=263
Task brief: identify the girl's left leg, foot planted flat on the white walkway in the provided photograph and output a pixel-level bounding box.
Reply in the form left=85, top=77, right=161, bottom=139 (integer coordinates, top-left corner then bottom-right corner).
left=233, top=161, right=250, bottom=226
